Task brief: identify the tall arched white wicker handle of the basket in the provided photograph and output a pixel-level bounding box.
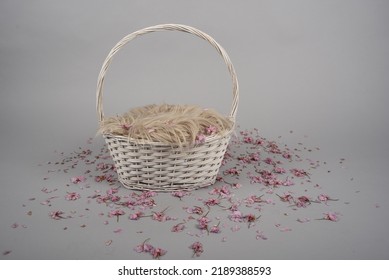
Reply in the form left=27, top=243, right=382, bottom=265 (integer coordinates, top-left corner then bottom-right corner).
left=96, top=24, right=239, bottom=122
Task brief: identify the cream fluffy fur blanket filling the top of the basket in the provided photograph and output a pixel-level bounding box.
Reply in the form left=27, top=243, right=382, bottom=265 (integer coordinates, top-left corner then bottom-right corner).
left=99, top=104, right=234, bottom=147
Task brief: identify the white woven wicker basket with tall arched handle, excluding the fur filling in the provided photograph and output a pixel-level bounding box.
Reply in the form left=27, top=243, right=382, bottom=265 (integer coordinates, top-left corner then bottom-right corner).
left=96, top=24, right=239, bottom=191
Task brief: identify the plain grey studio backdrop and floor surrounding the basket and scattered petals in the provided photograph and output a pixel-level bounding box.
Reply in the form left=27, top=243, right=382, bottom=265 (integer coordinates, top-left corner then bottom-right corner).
left=0, top=0, right=389, bottom=259
